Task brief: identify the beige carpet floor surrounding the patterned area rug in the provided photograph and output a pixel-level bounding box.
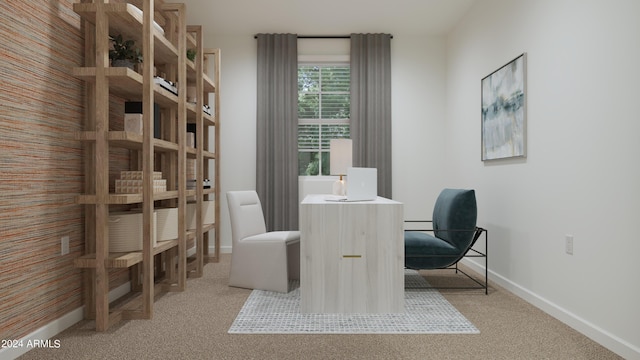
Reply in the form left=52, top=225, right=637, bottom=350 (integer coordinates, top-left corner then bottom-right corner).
left=17, top=254, right=622, bottom=360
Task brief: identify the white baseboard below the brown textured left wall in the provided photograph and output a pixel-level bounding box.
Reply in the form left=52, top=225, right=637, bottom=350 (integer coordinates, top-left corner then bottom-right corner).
left=0, top=282, right=131, bottom=360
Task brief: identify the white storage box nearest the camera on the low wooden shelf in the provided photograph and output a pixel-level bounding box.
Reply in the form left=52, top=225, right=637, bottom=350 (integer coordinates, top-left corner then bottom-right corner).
left=109, top=211, right=157, bottom=252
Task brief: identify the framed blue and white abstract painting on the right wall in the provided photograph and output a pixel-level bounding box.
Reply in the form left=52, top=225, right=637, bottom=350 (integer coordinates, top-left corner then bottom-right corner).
left=481, top=52, right=527, bottom=161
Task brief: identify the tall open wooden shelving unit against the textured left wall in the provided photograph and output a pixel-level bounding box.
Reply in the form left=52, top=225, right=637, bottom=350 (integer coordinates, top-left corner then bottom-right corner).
left=72, top=0, right=220, bottom=331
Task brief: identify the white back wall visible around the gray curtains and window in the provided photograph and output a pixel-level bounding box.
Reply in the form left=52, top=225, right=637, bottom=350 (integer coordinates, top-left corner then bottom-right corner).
left=204, top=34, right=446, bottom=252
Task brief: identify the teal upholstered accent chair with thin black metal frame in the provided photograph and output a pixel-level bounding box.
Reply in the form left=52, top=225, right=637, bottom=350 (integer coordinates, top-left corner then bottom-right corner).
left=404, top=189, right=488, bottom=293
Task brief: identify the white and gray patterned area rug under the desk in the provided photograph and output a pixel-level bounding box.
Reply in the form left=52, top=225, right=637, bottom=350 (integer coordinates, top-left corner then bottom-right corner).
left=229, top=270, right=480, bottom=334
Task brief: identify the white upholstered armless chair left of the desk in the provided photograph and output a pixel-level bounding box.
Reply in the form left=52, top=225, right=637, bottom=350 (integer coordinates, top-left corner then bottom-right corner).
left=227, top=191, right=300, bottom=293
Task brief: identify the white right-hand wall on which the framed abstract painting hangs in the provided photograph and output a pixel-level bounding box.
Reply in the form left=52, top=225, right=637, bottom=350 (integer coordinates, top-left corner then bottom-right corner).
left=446, top=0, right=640, bottom=358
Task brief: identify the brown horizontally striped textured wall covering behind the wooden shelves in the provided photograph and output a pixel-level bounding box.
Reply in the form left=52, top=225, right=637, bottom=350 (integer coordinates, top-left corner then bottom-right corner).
left=0, top=0, right=127, bottom=339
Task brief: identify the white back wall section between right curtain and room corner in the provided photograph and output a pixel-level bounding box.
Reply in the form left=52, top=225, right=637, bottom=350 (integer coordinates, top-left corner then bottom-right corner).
left=391, top=34, right=448, bottom=220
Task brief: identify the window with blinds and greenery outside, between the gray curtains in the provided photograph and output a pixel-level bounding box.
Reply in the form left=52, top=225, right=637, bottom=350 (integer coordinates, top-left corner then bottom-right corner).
left=298, top=64, right=351, bottom=176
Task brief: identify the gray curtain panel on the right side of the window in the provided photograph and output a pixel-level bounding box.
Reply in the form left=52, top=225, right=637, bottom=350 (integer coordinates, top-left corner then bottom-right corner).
left=351, top=34, right=391, bottom=198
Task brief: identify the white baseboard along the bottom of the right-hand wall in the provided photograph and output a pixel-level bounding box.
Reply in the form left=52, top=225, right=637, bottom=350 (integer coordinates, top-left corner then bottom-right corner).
left=462, top=259, right=640, bottom=360
